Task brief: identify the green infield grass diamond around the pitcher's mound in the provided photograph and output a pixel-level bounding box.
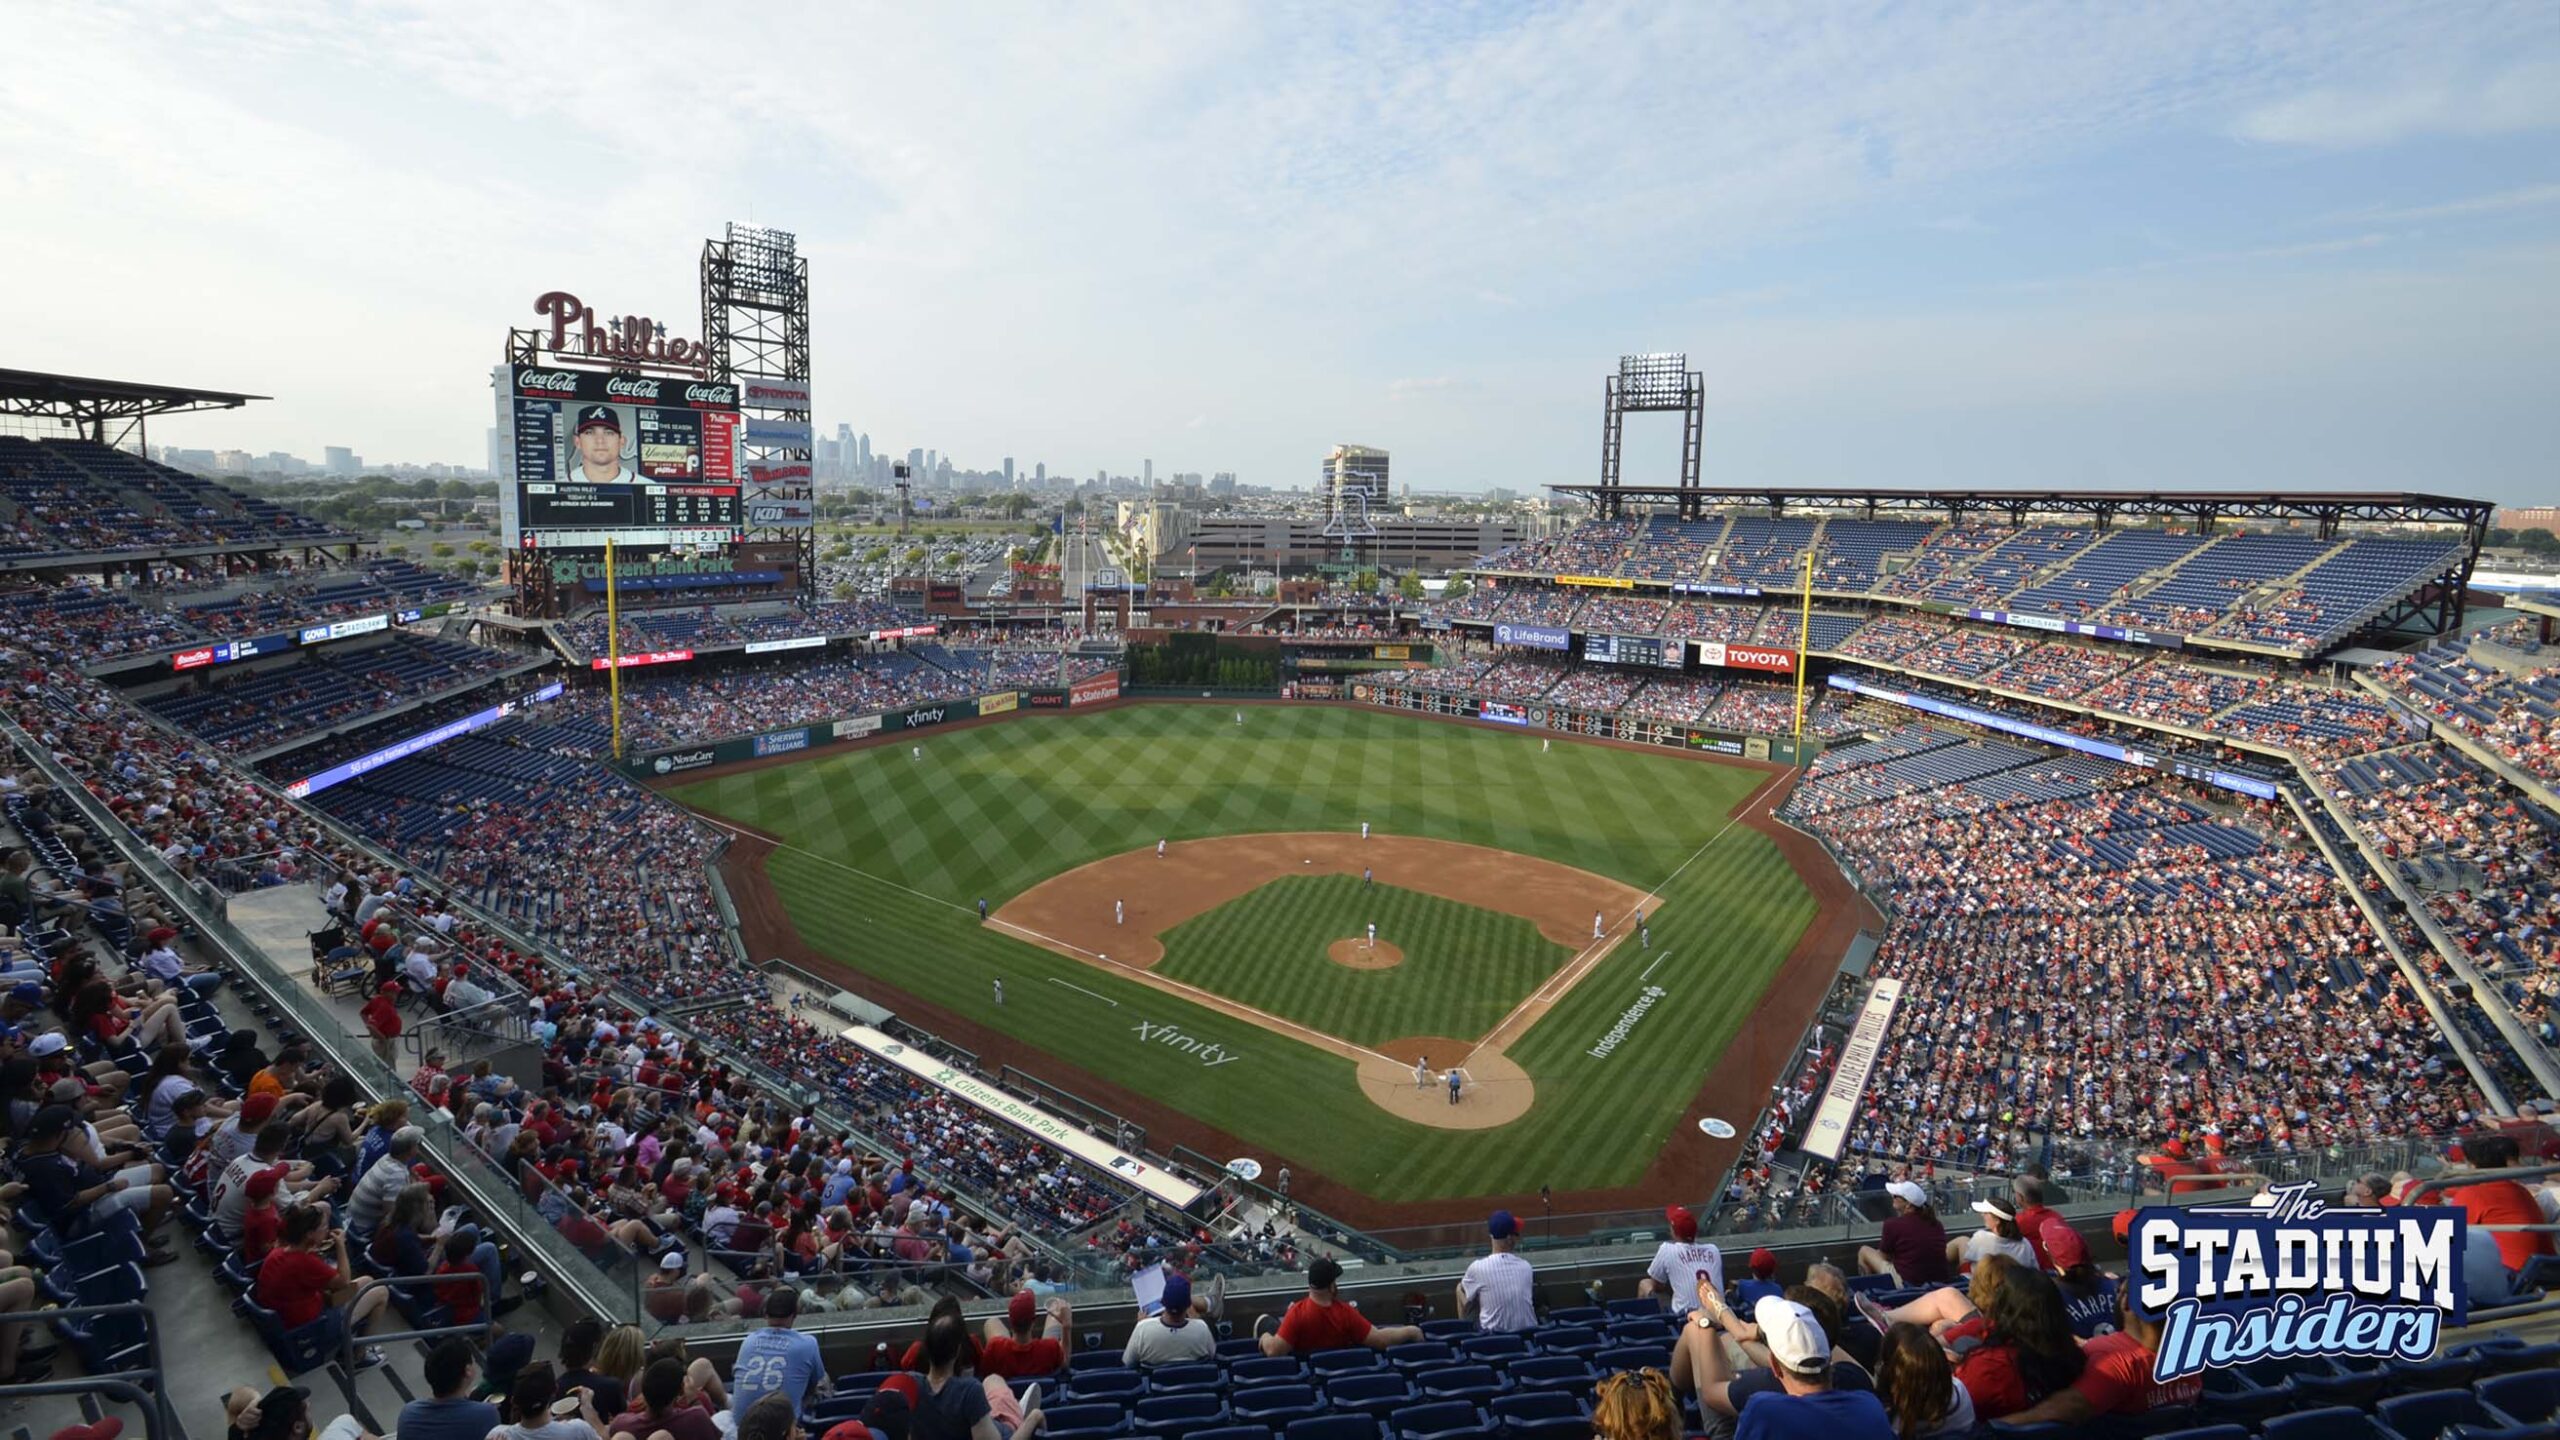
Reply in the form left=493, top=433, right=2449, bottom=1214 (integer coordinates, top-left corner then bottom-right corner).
left=1155, top=874, right=1572, bottom=1045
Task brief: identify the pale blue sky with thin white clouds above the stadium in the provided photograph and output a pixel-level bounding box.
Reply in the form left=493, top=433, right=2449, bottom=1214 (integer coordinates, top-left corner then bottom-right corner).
left=0, top=0, right=2560, bottom=502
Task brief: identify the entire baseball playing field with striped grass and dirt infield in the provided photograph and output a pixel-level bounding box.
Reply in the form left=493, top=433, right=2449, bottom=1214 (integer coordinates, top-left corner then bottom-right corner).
left=671, top=705, right=1836, bottom=1222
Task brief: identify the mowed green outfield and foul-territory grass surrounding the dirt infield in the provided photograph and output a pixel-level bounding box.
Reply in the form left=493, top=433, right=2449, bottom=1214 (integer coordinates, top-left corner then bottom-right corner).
left=676, top=705, right=1812, bottom=1199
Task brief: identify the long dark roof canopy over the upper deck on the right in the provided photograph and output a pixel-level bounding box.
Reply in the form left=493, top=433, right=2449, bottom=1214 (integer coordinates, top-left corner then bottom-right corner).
left=1549, top=484, right=2496, bottom=532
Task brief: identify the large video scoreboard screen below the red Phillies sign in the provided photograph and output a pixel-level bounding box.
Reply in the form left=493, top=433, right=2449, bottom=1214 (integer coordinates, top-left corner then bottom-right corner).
left=497, top=366, right=742, bottom=551
